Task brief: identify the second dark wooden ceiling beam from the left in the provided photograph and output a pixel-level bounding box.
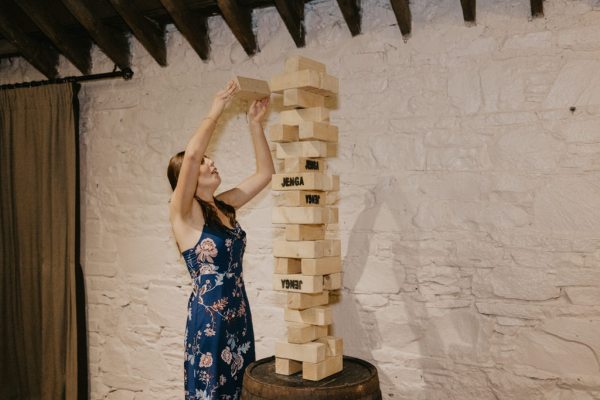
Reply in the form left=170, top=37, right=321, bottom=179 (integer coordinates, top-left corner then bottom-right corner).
left=16, top=0, right=92, bottom=74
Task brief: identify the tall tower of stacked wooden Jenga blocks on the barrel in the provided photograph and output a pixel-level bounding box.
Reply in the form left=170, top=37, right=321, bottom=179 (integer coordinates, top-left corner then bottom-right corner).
left=270, top=56, right=343, bottom=381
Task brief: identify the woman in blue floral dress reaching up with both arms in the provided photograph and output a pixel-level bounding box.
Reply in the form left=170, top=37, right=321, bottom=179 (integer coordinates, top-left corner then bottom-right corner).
left=167, top=81, right=275, bottom=400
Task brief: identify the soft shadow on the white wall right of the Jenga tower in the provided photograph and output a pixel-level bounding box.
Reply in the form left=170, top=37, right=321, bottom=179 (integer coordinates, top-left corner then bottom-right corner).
left=334, top=176, right=441, bottom=398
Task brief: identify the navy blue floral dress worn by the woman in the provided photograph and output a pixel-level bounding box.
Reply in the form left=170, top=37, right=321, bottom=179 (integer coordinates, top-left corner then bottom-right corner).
left=182, top=223, right=256, bottom=400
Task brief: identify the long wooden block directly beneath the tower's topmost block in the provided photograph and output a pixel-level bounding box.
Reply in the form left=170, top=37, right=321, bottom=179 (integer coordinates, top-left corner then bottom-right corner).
left=269, top=69, right=339, bottom=97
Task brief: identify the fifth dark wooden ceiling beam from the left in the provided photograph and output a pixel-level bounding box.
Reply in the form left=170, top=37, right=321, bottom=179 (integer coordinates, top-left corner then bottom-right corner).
left=160, top=0, right=210, bottom=61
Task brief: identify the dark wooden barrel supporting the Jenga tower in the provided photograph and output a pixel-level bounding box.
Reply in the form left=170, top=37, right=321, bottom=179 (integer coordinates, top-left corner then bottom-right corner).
left=242, top=356, right=381, bottom=400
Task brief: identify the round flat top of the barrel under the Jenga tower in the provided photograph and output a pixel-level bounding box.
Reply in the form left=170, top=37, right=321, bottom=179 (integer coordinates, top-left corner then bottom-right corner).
left=244, top=356, right=378, bottom=391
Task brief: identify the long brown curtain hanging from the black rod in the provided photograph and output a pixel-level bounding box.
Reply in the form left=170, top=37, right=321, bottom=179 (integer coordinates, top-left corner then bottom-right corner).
left=0, top=83, right=87, bottom=400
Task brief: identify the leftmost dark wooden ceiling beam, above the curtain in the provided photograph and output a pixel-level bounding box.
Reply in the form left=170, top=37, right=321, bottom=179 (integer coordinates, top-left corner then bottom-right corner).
left=0, top=1, right=58, bottom=79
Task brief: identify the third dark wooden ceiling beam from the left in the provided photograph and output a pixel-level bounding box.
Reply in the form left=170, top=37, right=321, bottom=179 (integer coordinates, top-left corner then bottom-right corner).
left=61, top=0, right=131, bottom=69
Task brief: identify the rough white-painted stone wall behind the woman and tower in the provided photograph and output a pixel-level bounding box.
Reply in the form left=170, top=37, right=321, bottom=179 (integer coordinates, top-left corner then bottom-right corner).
left=0, top=0, right=600, bottom=400
